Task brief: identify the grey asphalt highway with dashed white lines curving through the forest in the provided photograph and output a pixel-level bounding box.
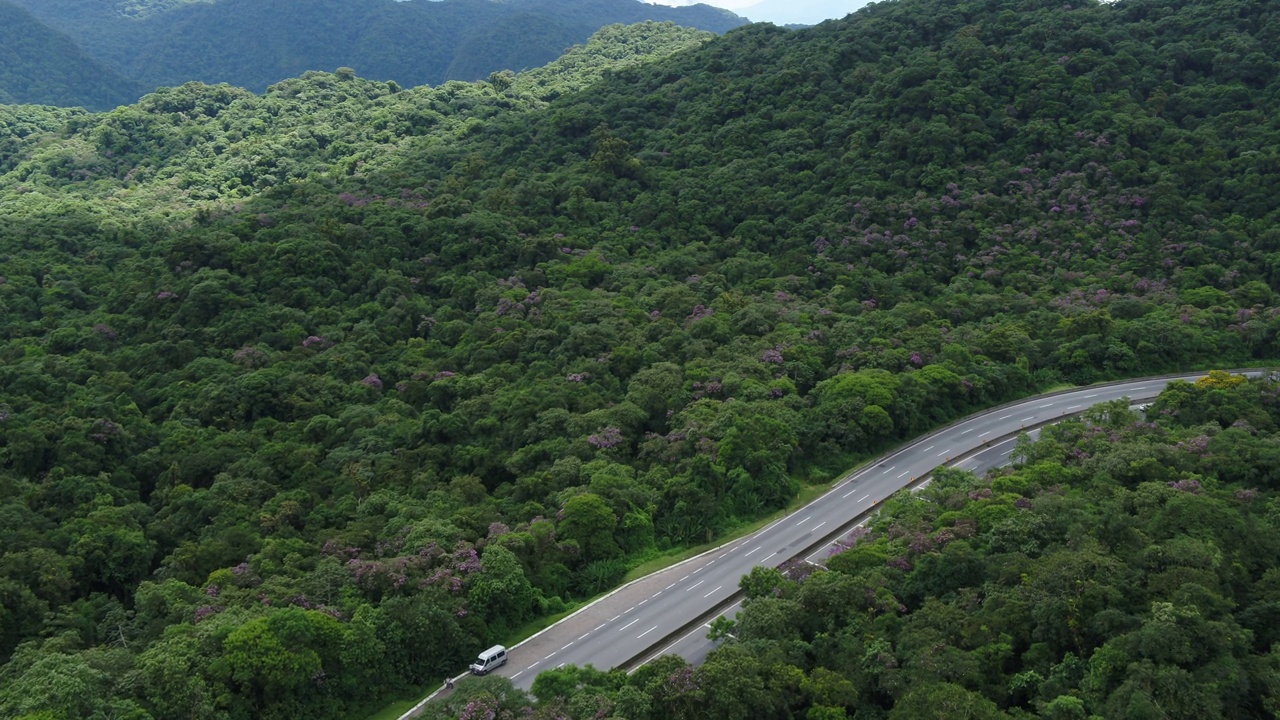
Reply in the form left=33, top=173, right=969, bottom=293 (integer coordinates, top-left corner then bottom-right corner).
left=409, top=373, right=1249, bottom=707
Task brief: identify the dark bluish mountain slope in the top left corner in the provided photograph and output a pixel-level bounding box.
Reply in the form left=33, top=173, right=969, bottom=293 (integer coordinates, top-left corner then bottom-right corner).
left=0, top=0, right=142, bottom=110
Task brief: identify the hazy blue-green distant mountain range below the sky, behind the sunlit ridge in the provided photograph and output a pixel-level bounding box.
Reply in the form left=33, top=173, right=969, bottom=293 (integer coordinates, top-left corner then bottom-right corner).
left=10, top=0, right=748, bottom=91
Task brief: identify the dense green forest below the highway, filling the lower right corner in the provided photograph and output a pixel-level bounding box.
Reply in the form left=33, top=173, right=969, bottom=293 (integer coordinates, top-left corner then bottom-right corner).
left=424, top=374, right=1280, bottom=720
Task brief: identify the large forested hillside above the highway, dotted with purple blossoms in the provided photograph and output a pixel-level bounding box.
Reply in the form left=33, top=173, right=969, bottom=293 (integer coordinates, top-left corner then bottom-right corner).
left=0, top=0, right=1280, bottom=717
